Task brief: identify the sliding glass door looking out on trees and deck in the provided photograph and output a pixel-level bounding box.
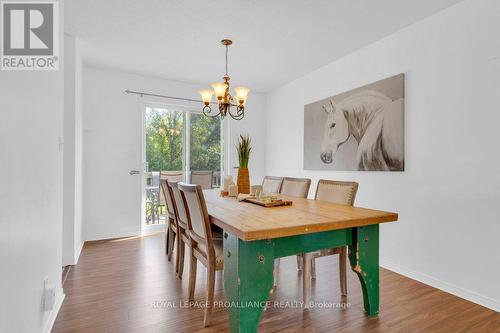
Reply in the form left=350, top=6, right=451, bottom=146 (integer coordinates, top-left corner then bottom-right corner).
left=143, top=105, right=224, bottom=225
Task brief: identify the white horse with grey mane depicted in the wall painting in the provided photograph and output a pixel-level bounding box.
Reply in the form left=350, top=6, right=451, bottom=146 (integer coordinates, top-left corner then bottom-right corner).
left=321, top=90, right=404, bottom=171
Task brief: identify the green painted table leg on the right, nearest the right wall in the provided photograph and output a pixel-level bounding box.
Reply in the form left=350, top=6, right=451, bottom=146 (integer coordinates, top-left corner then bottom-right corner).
left=349, top=224, right=379, bottom=316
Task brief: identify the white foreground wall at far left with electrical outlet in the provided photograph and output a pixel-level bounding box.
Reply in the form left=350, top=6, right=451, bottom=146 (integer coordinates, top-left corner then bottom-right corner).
left=0, top=7, right=63, bottom=332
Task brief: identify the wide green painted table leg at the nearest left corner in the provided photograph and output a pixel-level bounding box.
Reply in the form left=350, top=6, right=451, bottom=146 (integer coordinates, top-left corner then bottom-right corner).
left=224, top=233, right=274, bottom=333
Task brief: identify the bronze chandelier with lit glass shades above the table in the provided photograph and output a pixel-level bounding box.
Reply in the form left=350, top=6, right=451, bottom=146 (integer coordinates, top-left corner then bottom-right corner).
left=200, top=39, right=250, bottom=120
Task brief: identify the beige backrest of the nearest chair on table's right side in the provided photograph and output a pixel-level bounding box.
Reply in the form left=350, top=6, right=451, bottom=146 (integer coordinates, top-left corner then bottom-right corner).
left=314, top=179, right=358, bottom=206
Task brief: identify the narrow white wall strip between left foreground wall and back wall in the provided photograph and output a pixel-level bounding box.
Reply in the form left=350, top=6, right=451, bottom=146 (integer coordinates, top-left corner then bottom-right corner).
left=62, top=35, right=83, bottom=265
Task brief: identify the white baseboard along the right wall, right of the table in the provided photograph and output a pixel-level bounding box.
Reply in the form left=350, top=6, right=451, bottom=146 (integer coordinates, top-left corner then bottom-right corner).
left=380, top=260, right=500, bottom=312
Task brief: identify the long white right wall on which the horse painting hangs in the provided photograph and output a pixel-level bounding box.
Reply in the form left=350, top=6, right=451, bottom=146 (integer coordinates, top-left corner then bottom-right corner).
left=266, top=0, right=500, bottom=311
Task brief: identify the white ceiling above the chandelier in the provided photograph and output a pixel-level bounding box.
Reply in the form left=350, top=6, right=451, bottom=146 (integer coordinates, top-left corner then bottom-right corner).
left=65, top=0, right=460, bottom=92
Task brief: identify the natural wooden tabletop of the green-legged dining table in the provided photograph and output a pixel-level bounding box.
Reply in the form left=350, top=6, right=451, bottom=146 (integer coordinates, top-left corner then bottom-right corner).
left=204, top=190, right=398, bottom=241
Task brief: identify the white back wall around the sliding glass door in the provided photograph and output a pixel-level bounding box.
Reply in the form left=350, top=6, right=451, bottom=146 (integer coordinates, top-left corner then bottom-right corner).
left=83, top=66, right=265, bottom=240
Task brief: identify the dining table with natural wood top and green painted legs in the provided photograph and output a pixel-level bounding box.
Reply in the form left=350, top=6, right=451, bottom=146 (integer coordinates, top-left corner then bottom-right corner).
left=204, top=190, right=398, bottom=333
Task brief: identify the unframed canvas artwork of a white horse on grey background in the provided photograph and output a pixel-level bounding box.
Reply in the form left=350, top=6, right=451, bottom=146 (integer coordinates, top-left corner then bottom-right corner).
left=304, top=74, right=405, bottom=171
